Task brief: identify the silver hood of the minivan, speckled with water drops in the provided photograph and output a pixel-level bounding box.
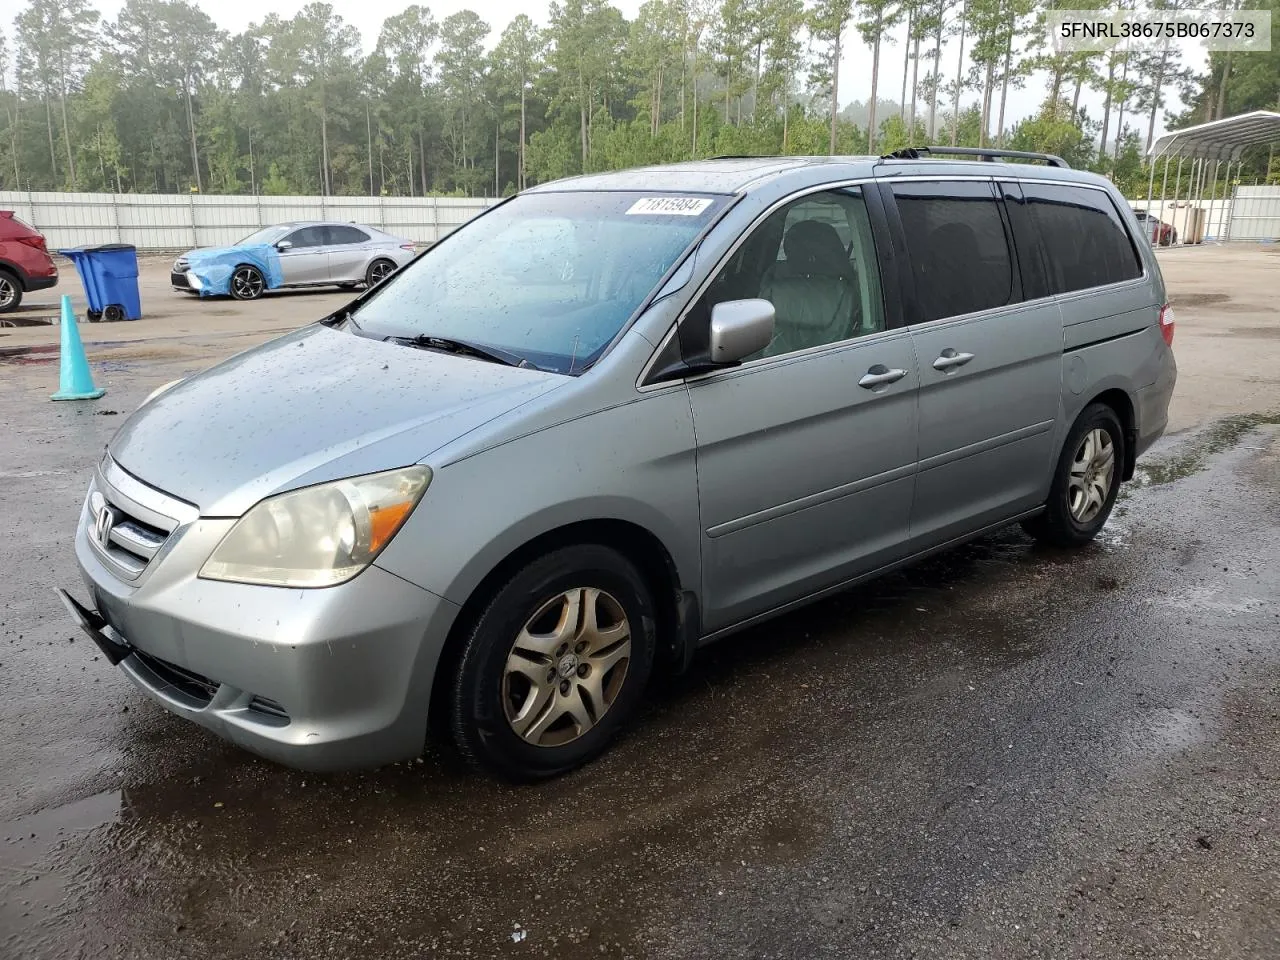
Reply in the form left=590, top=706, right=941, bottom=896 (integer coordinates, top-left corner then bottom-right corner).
left=108, top=325, right=566, bottom=517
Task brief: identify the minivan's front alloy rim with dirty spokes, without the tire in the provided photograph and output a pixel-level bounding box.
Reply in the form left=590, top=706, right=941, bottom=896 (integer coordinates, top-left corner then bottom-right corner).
left=502, top=588, right=631, bottom=746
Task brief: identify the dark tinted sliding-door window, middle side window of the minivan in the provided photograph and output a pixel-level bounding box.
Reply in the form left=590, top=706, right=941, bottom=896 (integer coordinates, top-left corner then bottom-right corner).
left=893, top=180, right=1014, bottom=320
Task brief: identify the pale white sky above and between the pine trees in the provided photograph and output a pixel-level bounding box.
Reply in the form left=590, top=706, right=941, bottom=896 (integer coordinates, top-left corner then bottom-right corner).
left=0, top=0, right=1207, bottom=144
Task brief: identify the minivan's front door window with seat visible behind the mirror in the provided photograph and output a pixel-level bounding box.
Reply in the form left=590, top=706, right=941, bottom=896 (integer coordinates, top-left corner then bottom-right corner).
left=690, top=187, right=884, bottom=360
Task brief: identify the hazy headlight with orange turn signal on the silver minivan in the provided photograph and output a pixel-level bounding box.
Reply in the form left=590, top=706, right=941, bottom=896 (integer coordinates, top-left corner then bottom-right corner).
left=200, top=467, right=431, bottom=586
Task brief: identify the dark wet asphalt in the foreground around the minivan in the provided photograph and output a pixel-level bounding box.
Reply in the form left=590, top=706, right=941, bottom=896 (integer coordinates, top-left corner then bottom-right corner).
left=0, top=356, right=1280, bottom=960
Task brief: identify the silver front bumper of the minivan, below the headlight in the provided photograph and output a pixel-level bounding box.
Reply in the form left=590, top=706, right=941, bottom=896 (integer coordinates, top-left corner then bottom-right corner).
left=67, top=467, right=457, bottom=771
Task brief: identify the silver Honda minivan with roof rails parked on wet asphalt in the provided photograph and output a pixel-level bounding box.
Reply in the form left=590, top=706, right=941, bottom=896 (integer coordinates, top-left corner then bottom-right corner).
left=61, top=150, right=1175, bottom=781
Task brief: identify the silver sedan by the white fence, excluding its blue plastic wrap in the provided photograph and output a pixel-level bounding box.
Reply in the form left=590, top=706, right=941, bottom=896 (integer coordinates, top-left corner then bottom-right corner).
left=169, top=220, right=417, bottom=300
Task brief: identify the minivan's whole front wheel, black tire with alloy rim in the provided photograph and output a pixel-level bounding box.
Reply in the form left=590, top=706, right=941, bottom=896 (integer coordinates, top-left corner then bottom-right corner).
left=449, top=544, right=655, bottom=783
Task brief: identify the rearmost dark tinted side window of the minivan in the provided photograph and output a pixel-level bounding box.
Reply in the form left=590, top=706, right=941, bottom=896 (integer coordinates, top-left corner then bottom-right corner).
left=1023, top=183, right=1142, bottom=293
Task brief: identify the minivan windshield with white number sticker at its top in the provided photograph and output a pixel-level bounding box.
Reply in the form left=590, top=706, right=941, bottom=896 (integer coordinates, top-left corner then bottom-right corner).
left=353, top=192, right=726, bottom=374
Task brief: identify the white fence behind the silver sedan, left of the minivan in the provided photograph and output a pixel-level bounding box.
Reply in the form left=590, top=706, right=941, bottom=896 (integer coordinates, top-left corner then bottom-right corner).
left=0, top=191, right=497, bottom=251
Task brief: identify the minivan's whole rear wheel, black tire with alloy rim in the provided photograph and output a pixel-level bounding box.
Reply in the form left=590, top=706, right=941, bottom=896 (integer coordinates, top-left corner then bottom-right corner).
left=1023, top=403, right=1125, bottom=547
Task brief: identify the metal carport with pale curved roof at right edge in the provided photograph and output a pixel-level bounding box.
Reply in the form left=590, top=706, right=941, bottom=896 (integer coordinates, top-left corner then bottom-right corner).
left=1147, top=110, right=1280, bottom=243
